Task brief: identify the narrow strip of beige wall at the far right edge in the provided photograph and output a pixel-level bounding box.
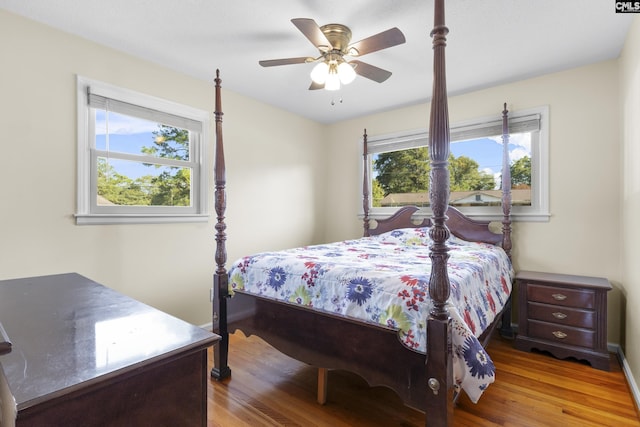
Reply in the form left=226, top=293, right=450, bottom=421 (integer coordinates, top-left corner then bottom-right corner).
left=620, top=17, right=640, bottom=404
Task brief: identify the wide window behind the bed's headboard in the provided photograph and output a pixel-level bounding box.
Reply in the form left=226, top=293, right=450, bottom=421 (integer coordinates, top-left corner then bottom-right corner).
left=367, top=107, right=549, bottom=221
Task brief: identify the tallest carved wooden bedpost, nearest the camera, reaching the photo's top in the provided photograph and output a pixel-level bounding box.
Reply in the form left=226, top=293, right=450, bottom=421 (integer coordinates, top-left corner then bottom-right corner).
left=425, top=0, right=453, bottom=426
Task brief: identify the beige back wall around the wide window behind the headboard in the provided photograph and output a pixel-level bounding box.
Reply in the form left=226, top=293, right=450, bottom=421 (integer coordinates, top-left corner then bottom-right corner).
left=325, top=61, right=621, bottom=343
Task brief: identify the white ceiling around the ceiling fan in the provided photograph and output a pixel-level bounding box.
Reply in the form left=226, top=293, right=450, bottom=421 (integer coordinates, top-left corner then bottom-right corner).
left=0, top=0, right=633, bottom=123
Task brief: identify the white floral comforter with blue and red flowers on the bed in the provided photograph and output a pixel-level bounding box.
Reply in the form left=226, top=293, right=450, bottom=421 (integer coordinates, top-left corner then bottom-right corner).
left=229, top=228, right=513, bottom=402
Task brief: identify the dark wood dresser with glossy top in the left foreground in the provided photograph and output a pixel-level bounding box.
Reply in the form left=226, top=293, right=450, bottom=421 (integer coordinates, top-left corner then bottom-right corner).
left=0, top=273, right=219, bottom=427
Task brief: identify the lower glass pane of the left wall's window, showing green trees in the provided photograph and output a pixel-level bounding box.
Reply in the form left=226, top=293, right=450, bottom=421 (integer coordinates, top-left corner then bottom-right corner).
left=97, top=157, right=191, bottom=206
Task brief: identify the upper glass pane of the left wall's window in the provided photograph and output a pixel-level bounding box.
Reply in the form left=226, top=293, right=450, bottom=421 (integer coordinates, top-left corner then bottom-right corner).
left=95, top=109, right=190, bottom=161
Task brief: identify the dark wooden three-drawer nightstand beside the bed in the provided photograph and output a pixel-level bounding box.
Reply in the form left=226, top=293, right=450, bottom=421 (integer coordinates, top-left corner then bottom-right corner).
left=515, top=271, right=611, bottom=371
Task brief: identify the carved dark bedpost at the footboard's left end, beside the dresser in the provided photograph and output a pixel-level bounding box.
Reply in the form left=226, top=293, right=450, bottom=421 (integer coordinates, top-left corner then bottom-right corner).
left=211, top=70, right=231, bottom=380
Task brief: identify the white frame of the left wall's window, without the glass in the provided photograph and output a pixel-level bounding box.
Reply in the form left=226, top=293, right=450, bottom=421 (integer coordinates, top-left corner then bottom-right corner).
left=75, top=76, right=210, bottom=225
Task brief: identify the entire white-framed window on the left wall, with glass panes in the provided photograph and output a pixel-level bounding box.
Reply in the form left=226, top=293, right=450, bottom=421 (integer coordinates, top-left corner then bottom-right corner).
left=76, top=77, right=209, bottom=224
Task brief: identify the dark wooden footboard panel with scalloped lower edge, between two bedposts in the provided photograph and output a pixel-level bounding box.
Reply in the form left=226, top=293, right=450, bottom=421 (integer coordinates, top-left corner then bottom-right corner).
left=229, top=292, right=427, bottom=411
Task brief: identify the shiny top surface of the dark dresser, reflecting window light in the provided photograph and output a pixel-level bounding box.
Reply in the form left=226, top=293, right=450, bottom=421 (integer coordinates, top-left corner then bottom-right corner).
left=0, top=273, right=219, bottom=408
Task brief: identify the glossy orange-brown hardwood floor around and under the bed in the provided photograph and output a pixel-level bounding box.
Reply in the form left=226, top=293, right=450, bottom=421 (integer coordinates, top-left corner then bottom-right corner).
left=208, top=332, right=640, bottom=427
